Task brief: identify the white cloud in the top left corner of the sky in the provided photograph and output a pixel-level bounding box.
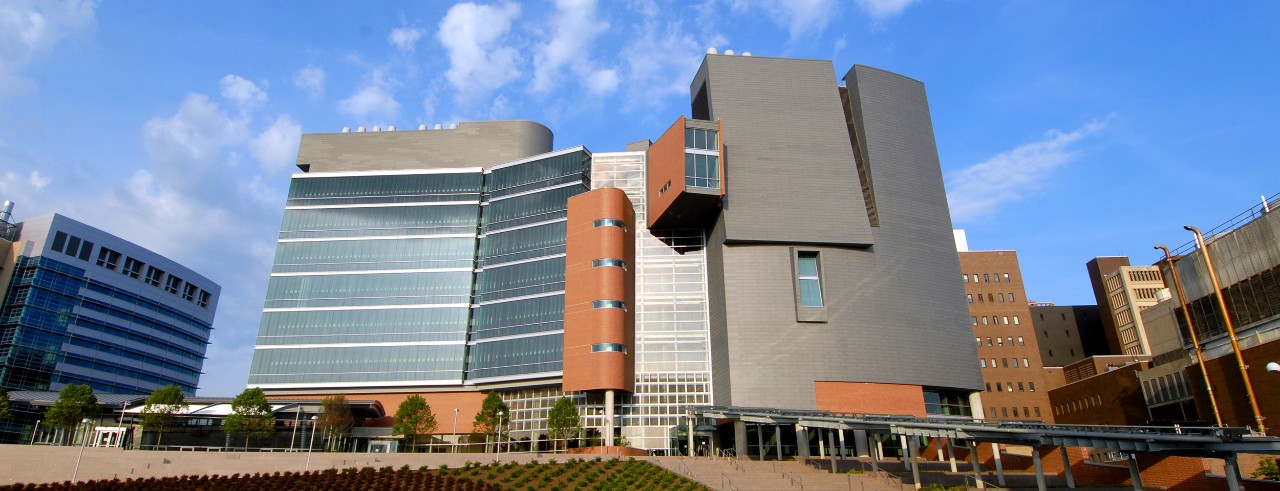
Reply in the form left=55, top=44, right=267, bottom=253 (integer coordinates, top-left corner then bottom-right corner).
left=0, top=0, right=97, bottom=100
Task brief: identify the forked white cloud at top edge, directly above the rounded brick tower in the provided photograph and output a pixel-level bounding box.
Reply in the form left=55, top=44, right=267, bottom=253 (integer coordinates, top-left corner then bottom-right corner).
left=532, top=0, right=618, bottom=95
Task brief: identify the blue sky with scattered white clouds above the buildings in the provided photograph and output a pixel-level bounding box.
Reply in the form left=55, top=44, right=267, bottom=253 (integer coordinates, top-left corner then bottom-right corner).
left=0, top=0, right=1280, bottom=395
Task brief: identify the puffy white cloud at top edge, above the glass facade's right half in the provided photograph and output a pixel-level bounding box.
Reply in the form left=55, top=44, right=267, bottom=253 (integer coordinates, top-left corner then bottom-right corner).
left=436, top=3, right=520, bottom=98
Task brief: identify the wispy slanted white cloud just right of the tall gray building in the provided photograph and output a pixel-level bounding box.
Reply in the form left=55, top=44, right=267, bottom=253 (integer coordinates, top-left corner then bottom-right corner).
left=947, top=120, right=1107, bottom=222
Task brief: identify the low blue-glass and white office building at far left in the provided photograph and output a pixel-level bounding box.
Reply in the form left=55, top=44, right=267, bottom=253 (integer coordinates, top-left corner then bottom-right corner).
left=0, top=215, right=220, bottom=395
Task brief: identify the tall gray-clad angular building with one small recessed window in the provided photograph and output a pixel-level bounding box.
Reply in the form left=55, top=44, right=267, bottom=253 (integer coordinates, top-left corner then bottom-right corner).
left=690, top=55, right=982, bottom=413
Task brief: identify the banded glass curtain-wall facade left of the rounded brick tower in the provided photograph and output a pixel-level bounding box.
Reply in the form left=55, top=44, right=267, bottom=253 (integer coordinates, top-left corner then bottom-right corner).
left=250, top=147, right=590, bottom=390
